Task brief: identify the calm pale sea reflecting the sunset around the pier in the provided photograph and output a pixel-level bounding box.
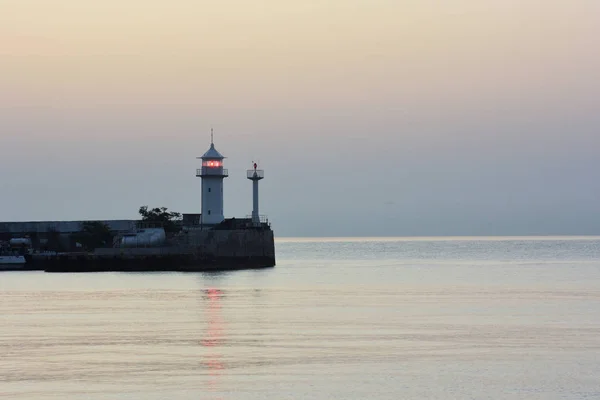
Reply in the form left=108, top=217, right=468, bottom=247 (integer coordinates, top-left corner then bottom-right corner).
left=0, top=237, right=600, bottom=400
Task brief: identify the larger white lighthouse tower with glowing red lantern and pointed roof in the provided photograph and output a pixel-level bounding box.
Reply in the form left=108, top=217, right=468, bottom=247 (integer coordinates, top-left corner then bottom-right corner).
left=196, top=129, right=229, bottom=226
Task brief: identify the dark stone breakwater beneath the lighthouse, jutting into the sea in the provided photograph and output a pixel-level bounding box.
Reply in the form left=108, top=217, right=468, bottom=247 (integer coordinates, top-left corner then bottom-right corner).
left=0, top=221, right=276, bottom=272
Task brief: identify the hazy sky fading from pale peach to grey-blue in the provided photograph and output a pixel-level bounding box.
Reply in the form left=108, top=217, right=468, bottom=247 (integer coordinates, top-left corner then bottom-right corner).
left=0, top=0, right=600, bottom=236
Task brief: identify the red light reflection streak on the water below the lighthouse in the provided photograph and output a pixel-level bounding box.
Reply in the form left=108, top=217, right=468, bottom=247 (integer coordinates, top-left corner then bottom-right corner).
left=202, top=289, right=224, bottom=391
